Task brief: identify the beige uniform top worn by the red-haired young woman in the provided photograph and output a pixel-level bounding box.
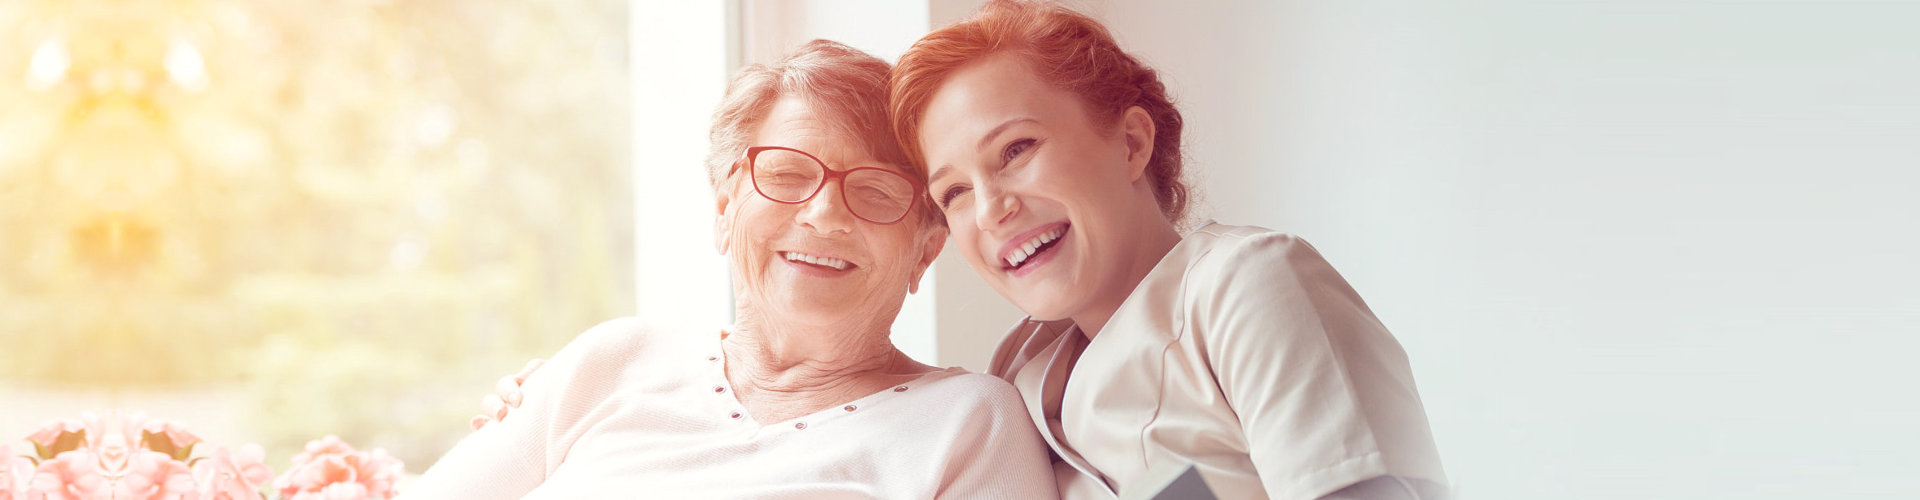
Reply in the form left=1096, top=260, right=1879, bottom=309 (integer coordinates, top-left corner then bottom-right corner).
left=991, top=223, right=1446, bottom=498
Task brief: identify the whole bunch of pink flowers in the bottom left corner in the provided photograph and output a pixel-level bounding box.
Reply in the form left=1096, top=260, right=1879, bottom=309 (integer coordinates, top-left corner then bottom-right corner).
left=0, top=412, right=405, bottom=500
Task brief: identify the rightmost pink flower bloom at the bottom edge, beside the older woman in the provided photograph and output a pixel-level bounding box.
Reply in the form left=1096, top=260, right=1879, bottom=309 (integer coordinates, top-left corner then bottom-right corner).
left=273, top=437, right=405, bottom=500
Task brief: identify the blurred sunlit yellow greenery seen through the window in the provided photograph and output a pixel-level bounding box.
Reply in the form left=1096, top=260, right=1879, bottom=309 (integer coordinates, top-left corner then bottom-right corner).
left=0, top=0, right=634, bottom=467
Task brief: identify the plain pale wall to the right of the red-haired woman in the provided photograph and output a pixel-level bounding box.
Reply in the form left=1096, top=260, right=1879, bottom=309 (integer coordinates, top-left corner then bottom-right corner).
left=1077, top=0, right=1920, bottom=498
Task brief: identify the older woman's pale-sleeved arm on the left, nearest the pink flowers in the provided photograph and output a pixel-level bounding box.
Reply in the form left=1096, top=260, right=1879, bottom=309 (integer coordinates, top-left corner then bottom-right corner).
left=403, top=321, right=636, bottom=498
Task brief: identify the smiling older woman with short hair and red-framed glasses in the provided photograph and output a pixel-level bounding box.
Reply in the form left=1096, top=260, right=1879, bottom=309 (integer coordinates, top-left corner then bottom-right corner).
left=405, top=40, right=1056, bottom=498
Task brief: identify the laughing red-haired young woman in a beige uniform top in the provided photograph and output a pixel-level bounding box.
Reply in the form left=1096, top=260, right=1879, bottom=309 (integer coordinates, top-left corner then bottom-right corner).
left=891, top=0, right=1446, bottom=498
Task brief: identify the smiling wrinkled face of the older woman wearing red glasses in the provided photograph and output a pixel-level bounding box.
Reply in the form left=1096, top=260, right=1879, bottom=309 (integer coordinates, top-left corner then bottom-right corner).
left=714, top=96, right=945, bottom=325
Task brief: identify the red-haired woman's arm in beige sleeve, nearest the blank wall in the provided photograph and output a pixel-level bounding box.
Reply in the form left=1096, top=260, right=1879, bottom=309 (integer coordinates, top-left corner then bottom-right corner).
left=1192, top=233, right=1442, bottom=498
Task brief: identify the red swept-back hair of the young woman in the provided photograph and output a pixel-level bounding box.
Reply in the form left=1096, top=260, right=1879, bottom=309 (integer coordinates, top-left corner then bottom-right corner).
left=889, top=0, right=1188, bottom=221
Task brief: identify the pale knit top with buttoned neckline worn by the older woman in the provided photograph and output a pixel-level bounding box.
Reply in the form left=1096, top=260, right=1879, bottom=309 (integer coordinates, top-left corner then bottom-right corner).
left=401, top=319, right=1056, bottom=500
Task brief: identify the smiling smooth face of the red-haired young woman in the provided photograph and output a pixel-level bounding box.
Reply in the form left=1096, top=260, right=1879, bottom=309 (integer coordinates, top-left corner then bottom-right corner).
left=920, top=54, right=1152, bottom=319
